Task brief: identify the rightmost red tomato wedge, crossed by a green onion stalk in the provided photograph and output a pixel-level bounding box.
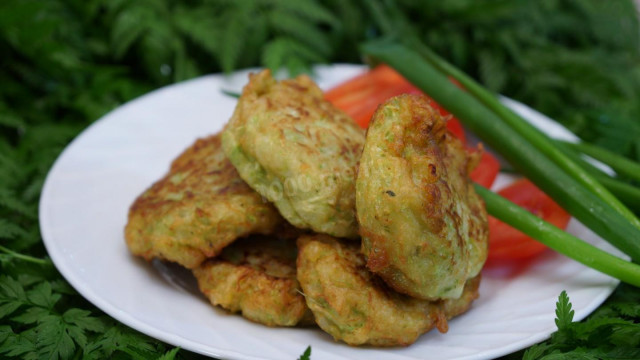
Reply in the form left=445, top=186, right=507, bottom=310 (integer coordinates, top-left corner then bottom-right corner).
left=487, top=179, right=571, bottom=263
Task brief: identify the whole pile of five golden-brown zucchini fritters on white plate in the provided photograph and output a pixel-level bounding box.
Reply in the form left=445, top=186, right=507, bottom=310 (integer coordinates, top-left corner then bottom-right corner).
left=125, top=71, right=487, bottom=346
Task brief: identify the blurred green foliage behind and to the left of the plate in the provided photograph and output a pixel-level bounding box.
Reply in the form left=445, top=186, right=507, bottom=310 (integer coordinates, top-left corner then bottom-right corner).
left=0, top=0, right=640, bottom=359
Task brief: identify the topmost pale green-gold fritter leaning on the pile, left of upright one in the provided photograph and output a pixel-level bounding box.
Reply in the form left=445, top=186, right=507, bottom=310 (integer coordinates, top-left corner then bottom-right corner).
left=222, top=70, right=364, bottom=238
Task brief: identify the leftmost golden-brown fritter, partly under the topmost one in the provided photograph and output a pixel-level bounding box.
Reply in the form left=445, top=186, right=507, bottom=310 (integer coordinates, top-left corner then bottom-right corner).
left=125, top=135, right=284, bottom=268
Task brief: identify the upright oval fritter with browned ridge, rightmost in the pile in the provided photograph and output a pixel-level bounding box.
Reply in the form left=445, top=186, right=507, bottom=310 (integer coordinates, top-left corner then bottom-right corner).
left=356, top=95, right=488, bottom=300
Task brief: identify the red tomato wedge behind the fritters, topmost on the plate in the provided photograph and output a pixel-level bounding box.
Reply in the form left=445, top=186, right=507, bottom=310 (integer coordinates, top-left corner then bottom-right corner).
left=325, top=65, right=466, bottom=144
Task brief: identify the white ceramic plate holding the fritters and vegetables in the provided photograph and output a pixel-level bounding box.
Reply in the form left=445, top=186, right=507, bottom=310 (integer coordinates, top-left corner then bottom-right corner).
left=40, top=65, right=617, bottom=360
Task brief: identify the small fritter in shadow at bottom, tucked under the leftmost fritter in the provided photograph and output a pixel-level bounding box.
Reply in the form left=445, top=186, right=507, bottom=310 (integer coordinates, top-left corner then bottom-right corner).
left=193, top=237, right=313, bottom=326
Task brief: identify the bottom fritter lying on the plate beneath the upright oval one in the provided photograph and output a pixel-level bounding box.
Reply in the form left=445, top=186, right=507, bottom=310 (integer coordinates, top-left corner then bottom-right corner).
left=297, top=235, right=480, bottom=346
